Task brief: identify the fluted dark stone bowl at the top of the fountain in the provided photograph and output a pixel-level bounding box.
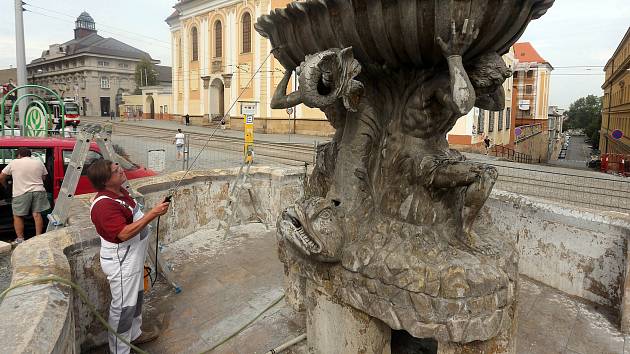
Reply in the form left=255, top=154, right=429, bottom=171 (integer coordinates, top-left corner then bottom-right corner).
left=254, top=0, right=554, bottom=69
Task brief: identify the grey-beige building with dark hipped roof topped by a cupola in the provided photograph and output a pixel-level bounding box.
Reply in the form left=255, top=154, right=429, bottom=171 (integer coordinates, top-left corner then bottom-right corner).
left=27, top=12, right=159, bottom=116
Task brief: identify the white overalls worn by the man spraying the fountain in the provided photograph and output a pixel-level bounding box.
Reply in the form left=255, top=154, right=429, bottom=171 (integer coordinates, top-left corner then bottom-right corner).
left=90, top=196, right=149, bottom=354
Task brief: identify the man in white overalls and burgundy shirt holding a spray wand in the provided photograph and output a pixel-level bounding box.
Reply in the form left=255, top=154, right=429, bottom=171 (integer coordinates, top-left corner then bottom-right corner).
left=87, top=160, right=169, bottom=354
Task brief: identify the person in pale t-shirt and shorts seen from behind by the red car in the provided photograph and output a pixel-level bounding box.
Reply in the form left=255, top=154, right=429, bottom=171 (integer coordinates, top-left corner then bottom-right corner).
left=0, top=147, right=50, bottom=243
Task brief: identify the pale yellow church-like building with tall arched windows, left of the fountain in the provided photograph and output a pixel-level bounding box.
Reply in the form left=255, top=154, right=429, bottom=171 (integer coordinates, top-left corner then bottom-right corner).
left=166, top=0, right=334, bottom=135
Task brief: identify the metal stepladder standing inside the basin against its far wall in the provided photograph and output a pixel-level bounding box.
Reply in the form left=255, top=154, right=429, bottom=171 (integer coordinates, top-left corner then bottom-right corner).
left=217, top=151, right=269, bottom=238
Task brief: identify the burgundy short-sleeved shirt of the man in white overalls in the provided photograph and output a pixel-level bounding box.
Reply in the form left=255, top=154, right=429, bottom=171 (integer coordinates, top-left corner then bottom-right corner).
left=90, top=188, right=136, bottom=243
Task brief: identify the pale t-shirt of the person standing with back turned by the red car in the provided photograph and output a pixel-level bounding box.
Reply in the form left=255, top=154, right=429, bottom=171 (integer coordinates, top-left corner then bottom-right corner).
left=2, top=157, right=48, bottom=197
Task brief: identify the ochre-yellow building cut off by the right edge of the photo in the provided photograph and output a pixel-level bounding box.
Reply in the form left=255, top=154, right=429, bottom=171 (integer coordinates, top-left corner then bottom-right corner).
left=599, top=28, right=630, bottom=154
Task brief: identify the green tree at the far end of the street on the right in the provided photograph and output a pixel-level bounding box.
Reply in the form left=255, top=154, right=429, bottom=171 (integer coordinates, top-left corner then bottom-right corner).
left=565, top=95, right=602, bottom=149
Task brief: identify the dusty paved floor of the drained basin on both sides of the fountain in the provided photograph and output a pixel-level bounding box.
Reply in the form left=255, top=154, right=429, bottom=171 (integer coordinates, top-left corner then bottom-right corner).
left=101, top=224, right=630, bottom=354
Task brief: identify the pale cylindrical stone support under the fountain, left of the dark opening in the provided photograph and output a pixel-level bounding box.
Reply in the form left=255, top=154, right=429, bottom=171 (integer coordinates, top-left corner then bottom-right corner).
left=305, top=282, right=391, bottom=354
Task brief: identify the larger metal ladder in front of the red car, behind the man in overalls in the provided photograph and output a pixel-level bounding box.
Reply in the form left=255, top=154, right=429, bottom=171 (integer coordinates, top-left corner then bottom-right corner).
left=46, top=124, right=131, bottom=232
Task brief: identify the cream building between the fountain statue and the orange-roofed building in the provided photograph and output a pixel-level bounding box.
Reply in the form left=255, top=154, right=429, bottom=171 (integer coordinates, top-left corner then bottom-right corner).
left=447, top=48, right=516, bottom=151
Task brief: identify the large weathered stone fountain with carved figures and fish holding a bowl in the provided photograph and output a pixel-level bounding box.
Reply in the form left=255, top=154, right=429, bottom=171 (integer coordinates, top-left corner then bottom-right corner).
left=255, top=0, right=553, bottom=354
